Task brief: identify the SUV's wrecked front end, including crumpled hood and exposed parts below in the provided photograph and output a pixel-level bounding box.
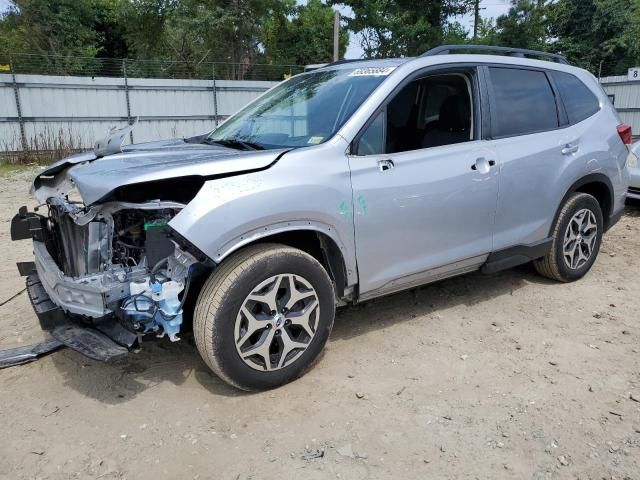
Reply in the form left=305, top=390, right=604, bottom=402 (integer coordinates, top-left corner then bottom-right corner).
left=11, top=127, right=285, bottom=360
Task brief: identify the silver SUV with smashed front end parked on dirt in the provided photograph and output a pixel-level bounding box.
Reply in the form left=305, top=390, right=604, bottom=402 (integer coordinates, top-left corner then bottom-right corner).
left=12, top=46, right=631, bottom=390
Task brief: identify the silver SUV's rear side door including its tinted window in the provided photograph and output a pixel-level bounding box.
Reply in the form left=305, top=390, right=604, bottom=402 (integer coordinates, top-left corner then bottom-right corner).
left=485, top=65, right=580, bottom=251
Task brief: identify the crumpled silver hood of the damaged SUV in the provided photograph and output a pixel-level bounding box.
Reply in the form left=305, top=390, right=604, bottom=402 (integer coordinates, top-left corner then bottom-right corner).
left=31, top=140, right=286, bottom=205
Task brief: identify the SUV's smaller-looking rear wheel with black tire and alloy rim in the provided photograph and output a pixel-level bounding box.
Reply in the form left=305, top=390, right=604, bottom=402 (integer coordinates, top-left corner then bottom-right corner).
left=533, top=193, right=604, bottom=282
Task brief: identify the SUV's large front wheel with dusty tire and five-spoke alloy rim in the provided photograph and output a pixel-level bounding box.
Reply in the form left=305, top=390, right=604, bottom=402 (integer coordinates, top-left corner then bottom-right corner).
left=193, top=244, right=335, bottom=391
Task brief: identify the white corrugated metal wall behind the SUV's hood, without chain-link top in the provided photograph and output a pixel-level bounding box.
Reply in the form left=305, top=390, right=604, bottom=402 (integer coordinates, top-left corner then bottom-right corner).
left=0, top=74, right=277, bottom=151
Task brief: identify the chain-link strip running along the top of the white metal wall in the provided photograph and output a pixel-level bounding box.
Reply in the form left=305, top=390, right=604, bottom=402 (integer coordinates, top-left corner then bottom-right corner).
left=0, top=52, right=304, bottom=81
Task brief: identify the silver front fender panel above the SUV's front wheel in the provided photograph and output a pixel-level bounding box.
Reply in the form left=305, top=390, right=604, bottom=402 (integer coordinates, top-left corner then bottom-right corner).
left=170, top=143, right=357, bottom=285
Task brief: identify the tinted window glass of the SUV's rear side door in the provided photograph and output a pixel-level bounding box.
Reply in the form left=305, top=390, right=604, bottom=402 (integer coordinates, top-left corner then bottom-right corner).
left=489, top=67, right=559, bottom=137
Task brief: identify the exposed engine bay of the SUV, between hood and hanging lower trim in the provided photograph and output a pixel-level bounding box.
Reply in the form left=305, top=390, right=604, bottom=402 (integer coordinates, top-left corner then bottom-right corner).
left=19, top=197, right=197, bottom=341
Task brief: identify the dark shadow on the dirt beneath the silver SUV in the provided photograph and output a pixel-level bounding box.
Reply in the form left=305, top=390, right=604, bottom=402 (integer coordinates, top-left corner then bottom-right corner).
left=50, top=265, right=540, bottom=404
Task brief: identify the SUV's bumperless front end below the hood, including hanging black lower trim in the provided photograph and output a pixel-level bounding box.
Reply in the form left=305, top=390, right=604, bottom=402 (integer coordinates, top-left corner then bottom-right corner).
left=11, top=174, right=200, bottom=360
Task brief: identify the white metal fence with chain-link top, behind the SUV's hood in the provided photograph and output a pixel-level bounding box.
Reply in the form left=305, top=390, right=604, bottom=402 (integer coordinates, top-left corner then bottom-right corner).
left=0, top=52, right=304, bottom=161
